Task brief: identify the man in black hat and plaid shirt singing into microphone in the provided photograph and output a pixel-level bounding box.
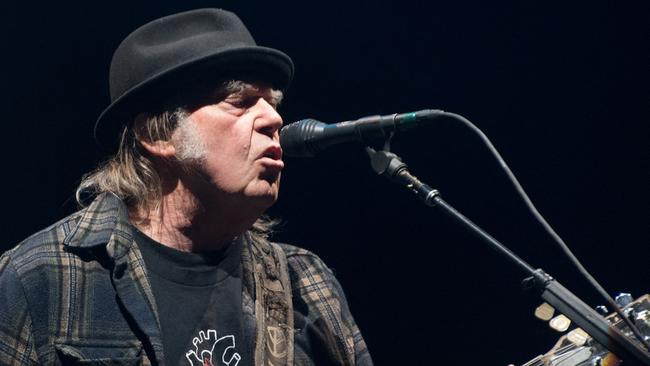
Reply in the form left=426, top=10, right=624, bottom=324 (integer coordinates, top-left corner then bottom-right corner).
left=0, top=9, right=372, bottom=366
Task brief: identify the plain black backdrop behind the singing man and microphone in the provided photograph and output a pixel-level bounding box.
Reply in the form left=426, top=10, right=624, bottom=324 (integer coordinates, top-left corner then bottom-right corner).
left=0, top=0, right=650, bottom=365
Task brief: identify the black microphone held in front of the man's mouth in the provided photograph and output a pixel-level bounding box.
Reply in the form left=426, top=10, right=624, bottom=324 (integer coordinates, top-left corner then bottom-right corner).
left=280, top=109, right=445, bottom=158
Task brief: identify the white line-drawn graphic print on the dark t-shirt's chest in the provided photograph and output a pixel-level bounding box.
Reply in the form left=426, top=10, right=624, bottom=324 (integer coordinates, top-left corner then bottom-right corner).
left=185, top=329, right=241, bottom=366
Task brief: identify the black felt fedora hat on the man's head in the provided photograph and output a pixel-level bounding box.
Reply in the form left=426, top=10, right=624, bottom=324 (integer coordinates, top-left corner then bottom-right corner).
left=95, top=9, right=293, bottom=148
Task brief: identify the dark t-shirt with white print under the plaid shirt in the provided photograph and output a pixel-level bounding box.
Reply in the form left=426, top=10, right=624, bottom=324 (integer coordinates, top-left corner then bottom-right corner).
left=134, top=230, right=253, bottom=366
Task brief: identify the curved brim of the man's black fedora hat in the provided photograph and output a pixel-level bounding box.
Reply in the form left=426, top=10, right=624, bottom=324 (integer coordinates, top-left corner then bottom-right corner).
left=94, top=46, right=293, bottom=150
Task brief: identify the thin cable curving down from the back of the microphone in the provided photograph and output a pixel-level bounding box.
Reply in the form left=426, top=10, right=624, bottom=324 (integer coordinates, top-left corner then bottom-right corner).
left=436, top=111, right=650, bottom=351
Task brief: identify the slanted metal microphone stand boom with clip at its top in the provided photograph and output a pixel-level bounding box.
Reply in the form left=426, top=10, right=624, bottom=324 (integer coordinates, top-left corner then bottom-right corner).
left=366, top=147, right=650, bottom=366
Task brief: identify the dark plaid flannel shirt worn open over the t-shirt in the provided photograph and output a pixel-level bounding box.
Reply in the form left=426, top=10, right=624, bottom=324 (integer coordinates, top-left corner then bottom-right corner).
left=0, top=194, right=372, bottom=365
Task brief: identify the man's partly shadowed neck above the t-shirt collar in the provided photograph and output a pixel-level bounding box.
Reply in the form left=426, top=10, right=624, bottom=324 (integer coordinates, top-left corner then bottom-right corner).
left=130, top=179, right=261, bottom=252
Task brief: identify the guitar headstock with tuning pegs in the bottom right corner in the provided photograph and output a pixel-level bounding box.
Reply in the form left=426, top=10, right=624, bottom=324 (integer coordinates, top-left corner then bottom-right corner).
left=522, top=294, right=650, bottom=366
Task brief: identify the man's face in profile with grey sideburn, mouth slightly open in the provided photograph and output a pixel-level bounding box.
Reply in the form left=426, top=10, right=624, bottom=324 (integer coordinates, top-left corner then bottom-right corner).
left=172, top=84, right=284, bottom=208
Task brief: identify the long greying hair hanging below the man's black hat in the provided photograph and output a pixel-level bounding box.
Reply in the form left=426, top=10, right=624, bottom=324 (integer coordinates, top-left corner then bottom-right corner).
left=76, top=80, right=282, bottom=241
